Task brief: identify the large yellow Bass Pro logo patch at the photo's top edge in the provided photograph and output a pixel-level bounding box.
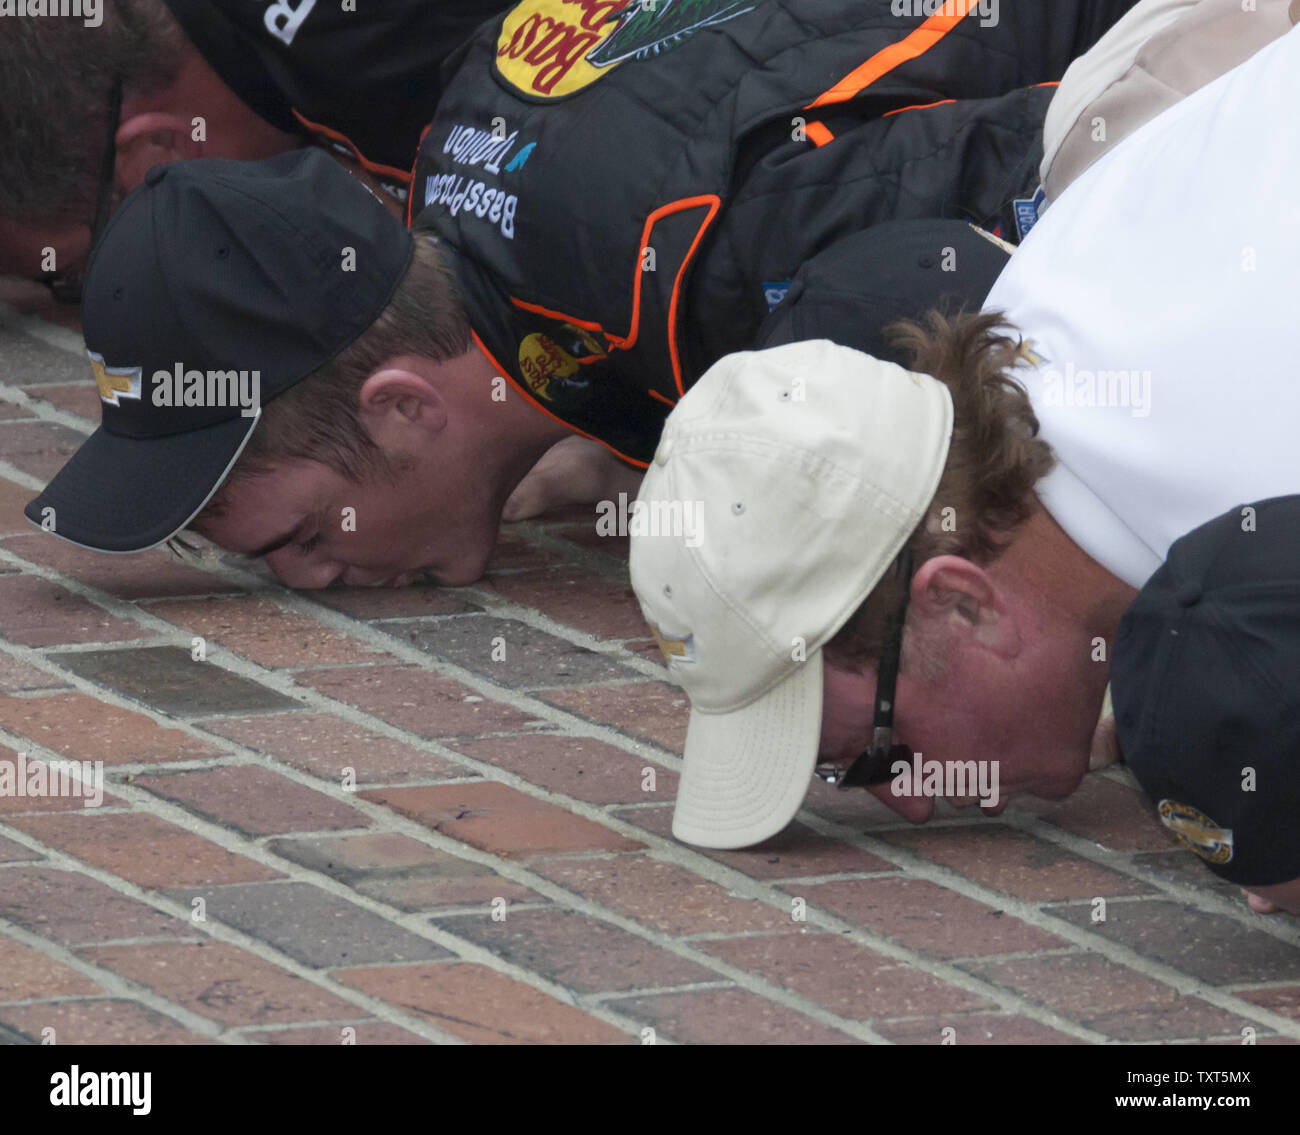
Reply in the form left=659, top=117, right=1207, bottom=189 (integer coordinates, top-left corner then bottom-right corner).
left=497, top=0, right=763, bottom=99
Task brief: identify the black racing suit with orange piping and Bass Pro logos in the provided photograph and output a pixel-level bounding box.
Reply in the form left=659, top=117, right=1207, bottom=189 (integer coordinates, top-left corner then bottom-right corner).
left=411, top=0, right=1134, bottom=463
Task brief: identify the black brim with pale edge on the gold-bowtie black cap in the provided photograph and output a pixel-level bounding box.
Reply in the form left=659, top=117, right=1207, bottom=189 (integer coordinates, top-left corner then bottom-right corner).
left=23, top=410, right=261, bottom=551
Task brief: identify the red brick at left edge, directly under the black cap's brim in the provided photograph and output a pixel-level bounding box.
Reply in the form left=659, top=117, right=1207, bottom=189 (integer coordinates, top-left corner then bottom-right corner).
left=4, top=524, right=238, bottom=603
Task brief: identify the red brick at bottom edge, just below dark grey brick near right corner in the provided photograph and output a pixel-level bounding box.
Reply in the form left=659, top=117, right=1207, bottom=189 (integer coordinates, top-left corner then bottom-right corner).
left=966, top=954, right=1242, bottom=1040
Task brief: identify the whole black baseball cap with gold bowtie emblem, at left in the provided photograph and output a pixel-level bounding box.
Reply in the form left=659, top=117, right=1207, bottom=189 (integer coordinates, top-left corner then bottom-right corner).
left=26, top=150, right=413, bottom=551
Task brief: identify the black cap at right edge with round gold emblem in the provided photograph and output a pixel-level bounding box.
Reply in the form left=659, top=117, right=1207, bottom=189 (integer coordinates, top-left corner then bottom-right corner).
left=1110, top=497, right=1300, bottom=887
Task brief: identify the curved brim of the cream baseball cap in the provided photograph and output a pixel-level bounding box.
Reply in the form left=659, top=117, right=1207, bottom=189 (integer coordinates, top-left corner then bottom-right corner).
left=672, top=651, right=822, bottom=849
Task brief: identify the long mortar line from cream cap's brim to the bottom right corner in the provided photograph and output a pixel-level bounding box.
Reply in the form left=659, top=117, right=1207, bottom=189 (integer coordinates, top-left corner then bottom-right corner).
left=785, top=818, right=1300, bottom=1037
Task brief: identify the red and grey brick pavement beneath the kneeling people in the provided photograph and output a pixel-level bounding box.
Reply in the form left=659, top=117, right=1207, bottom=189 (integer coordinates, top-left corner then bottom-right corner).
left=0, top=308, right=1300, bottom=1044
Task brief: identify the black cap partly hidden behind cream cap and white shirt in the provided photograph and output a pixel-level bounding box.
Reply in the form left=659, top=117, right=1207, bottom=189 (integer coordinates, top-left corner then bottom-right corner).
left=755, top=221, right=1015, bottom=367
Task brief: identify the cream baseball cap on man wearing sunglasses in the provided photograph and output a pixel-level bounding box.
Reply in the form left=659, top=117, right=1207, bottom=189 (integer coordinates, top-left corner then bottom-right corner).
left=629, top=339, right=953, bottom=848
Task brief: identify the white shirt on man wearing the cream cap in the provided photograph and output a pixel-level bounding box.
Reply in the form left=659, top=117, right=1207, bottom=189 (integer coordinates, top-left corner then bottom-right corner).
left=985, top=27, right=1300, bottom=588
